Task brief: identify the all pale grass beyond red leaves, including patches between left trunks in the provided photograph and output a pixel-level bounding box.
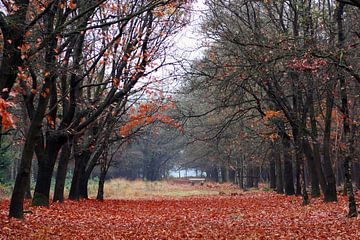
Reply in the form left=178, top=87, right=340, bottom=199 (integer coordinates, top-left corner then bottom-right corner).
left=0, top=175, right=243, bottom=199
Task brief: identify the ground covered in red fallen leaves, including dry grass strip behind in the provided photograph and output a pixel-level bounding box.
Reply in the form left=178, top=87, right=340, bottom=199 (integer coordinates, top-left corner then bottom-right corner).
left=0, top=182, right=360, bottom=239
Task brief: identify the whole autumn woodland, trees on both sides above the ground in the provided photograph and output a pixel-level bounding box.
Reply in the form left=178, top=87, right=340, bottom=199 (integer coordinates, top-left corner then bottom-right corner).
left=0, top=0, right=360, bottom=237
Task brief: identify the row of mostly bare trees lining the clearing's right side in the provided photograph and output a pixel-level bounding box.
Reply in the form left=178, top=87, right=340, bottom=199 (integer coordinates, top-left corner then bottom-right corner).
left=179, top=0, right=360, bottom=217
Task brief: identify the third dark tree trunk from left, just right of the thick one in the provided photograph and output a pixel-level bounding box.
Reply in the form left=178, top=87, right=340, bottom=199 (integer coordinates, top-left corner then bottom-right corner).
left=54, top=142, right=71, bottom=203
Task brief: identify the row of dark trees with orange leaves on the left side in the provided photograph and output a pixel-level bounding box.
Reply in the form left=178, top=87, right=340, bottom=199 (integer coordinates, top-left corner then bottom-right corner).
left=0, top=0, right=187, bottom=218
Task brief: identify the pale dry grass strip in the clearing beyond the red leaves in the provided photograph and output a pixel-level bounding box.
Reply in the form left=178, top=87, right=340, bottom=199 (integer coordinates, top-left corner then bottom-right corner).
left=89, top=179, right=240, bottom=199
